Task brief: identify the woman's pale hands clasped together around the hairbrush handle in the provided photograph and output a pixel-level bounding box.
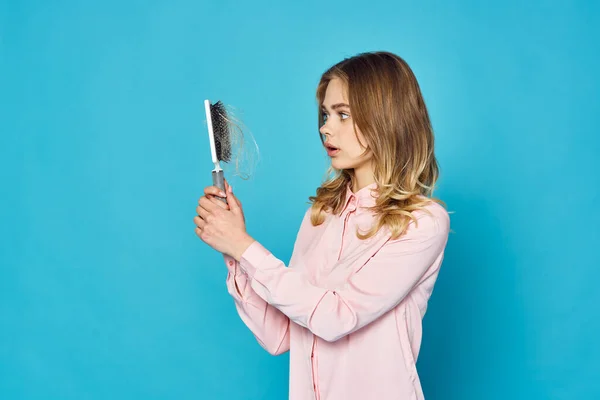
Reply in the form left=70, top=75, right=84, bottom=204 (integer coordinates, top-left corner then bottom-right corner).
left=194, top=181, right=254, bottom=261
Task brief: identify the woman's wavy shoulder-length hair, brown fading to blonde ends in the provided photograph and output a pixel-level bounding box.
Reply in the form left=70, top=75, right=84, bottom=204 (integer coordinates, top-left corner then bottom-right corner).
left=309, top=52, right=444, bottom=240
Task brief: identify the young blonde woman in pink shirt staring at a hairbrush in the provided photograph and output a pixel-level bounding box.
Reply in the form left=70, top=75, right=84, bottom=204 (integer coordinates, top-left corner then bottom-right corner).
left=194, top=52, right=450, bottom=400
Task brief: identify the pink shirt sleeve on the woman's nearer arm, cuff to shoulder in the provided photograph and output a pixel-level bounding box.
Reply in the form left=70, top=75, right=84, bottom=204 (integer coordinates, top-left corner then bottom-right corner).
left=239, top=210, right=450, bottom=342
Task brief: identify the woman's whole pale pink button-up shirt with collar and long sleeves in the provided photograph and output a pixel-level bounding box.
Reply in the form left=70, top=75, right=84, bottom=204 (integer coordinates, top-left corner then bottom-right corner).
left=224, top=184, right=450, bottom=400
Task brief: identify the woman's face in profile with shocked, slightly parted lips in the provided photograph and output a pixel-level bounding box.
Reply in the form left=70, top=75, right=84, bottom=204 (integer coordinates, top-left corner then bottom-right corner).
left=319, top=78, right=373, bottom=172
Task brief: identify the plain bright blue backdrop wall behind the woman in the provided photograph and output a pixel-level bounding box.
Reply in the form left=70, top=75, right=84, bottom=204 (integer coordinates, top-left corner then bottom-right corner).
left=0, top=0, right=600, bottom=400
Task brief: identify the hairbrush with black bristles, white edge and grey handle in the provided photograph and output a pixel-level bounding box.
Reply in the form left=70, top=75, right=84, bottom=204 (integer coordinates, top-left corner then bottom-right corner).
left=204, top=100, right=231, bottom=202
